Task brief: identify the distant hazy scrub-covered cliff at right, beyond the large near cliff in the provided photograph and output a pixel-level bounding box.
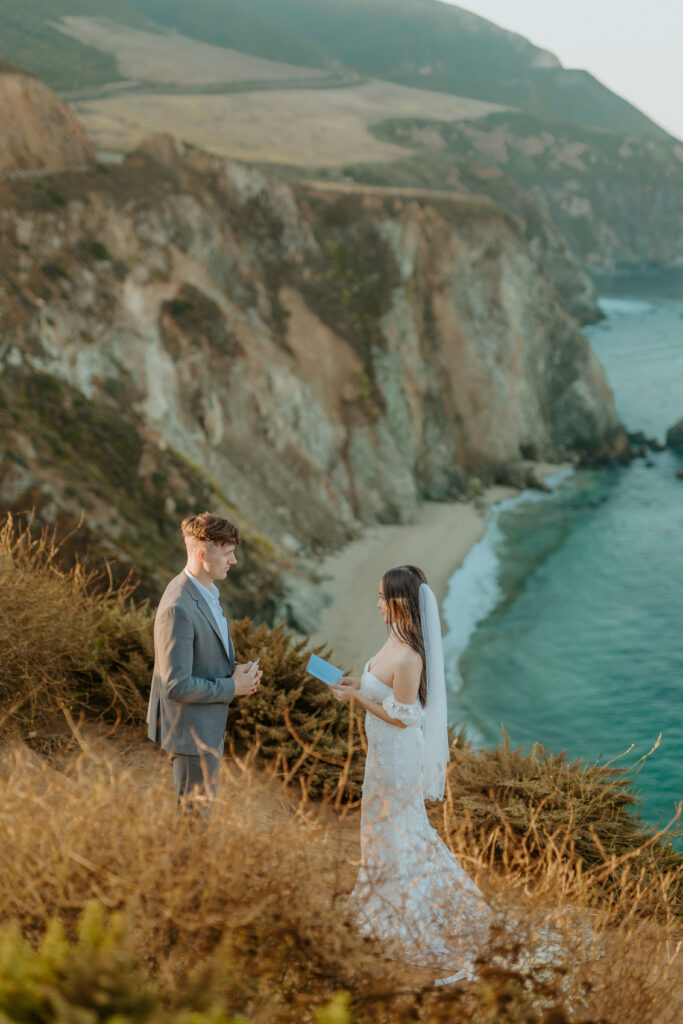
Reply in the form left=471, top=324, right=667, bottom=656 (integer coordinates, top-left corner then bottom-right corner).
left=375, top=112, right=683, bottom=271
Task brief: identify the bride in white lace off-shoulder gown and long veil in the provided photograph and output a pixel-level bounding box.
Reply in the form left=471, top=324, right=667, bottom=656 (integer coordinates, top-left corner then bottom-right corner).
left=332, top=565, right=492, bottom=980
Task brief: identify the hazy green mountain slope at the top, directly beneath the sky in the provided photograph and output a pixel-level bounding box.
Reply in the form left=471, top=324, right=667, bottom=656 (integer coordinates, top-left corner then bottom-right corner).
left=131, top=0, right=666, bottom=137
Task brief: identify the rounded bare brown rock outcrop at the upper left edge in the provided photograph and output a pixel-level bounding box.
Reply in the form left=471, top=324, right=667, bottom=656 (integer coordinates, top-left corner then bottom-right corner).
left=0, top=63, right=95, bottom=175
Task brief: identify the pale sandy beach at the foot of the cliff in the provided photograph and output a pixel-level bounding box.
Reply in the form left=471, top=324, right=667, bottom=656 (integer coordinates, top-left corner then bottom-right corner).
left=311, top=483, right=516, bottom=672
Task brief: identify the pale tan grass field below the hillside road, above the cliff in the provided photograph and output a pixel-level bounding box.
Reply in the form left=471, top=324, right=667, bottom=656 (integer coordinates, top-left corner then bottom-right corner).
left=72, top=81, right=501, bottom=167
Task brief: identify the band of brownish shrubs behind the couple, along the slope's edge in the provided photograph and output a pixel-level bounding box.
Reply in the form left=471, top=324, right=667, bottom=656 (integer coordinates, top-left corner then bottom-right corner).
left=0, top=518, right=683, bottom=919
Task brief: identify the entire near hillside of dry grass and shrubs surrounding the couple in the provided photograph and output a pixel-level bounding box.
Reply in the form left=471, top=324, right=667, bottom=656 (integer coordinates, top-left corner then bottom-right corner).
left=0, top=520, right=683, bottom=1024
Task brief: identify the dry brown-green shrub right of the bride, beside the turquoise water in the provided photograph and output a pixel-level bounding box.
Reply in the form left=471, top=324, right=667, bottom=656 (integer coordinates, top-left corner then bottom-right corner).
left=432, top=730, right=683, bottom=924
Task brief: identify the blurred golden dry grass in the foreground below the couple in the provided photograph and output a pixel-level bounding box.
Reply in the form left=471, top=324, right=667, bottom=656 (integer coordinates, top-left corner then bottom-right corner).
left=0, top=727, right=683, bottom=1024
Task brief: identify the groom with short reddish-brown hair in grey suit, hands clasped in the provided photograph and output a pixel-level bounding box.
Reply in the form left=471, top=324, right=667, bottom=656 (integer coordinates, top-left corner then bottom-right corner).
left=147, top=512, right=261, bottom=808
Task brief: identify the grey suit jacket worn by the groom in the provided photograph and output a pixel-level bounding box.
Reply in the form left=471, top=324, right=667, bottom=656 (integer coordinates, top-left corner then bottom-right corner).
left=147, top=572, right=234, bottom=754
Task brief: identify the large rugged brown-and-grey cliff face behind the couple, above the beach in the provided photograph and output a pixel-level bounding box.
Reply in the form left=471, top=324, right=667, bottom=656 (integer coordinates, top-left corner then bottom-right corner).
left=0, top=138, right=625, bottom=627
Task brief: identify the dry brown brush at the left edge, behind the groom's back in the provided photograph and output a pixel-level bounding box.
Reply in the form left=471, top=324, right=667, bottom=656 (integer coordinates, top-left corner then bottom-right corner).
left=0, top=516, right=152, bottom=734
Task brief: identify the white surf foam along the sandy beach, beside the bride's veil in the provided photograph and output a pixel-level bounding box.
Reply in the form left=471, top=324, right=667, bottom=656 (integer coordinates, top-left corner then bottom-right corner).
left=441, top=468, right=573, bottom=692
